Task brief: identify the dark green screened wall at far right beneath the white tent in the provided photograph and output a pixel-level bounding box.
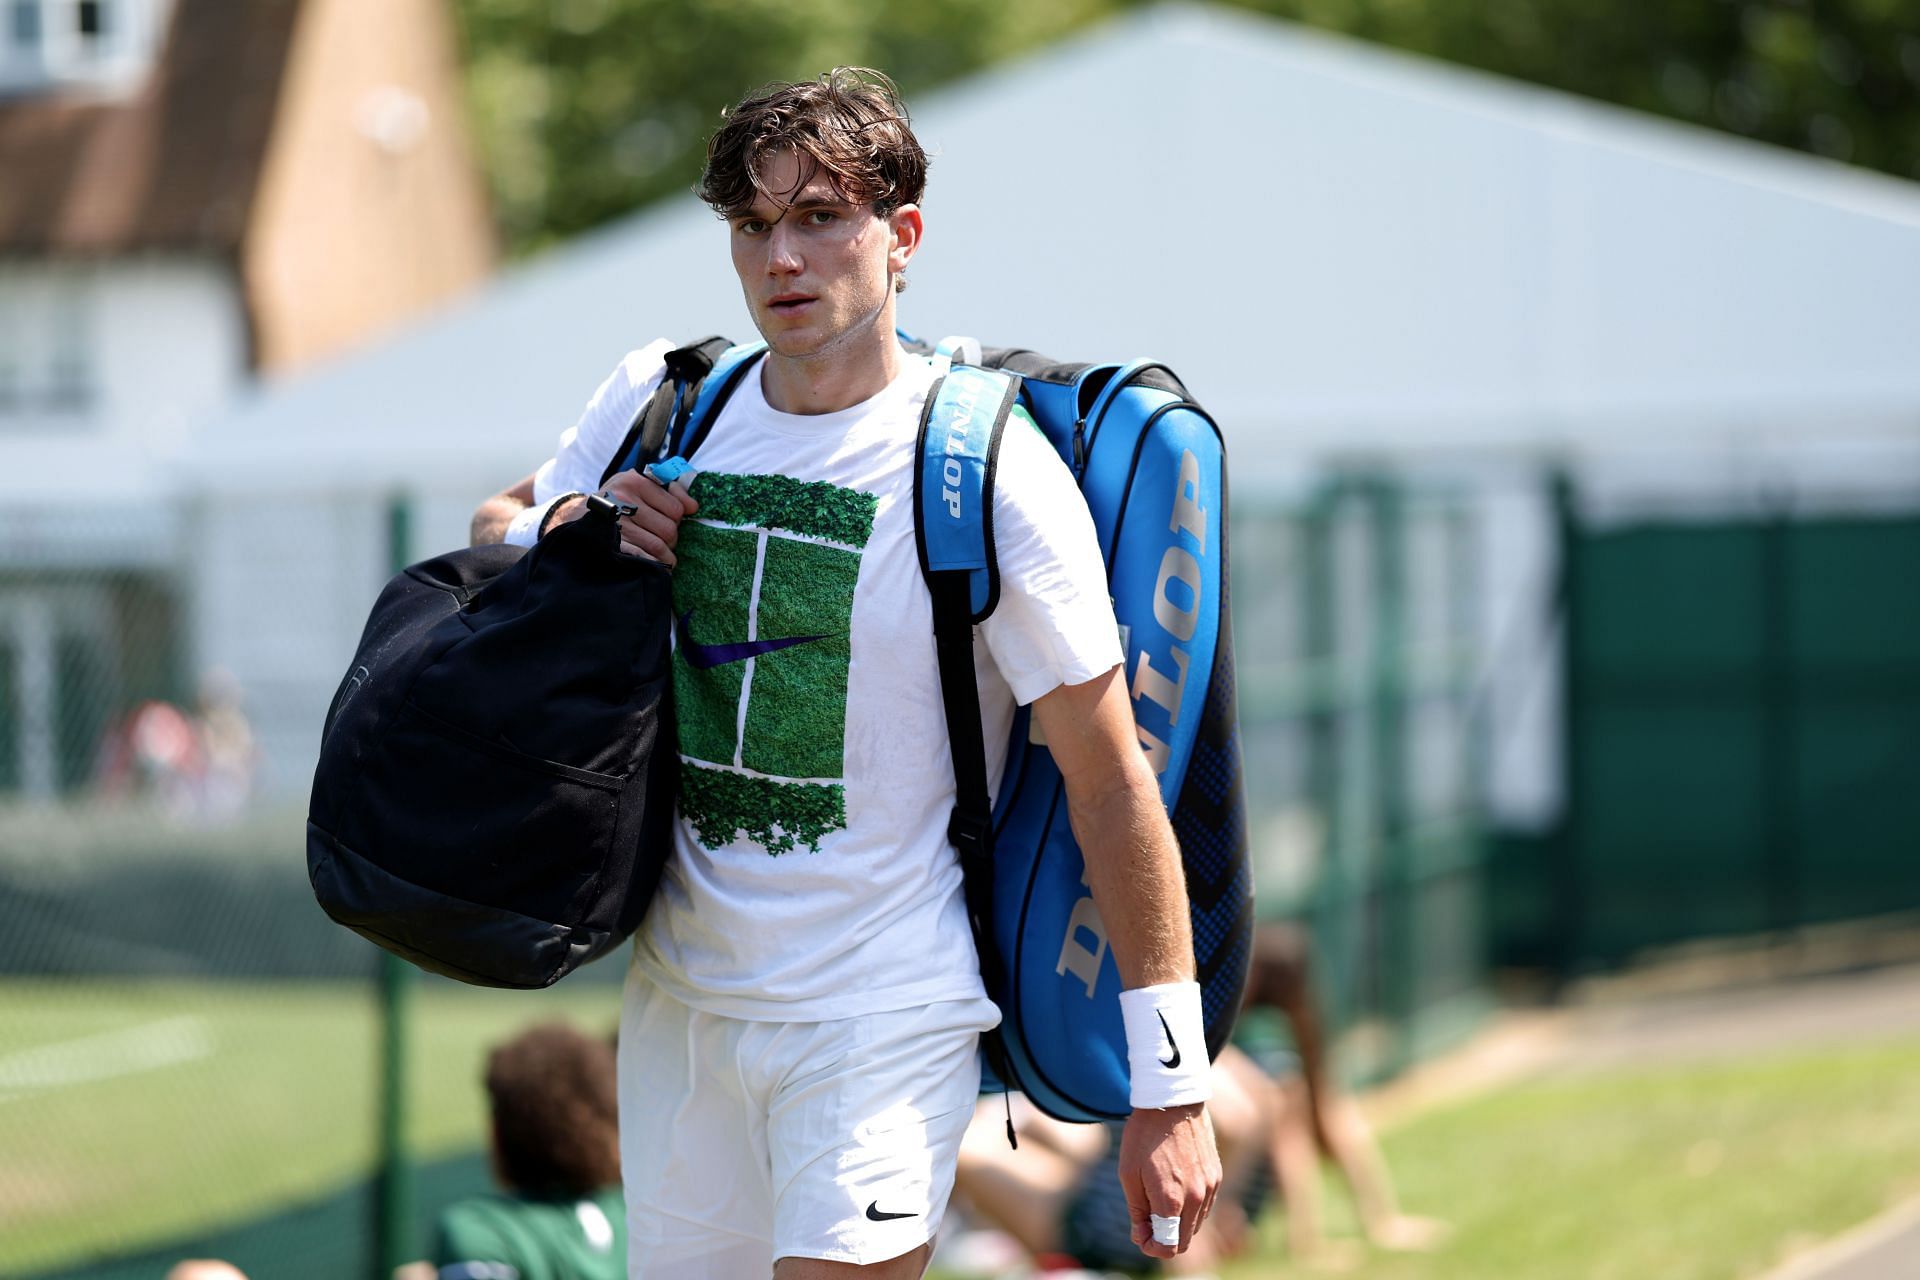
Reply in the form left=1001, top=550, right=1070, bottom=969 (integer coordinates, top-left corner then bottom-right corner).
left=1492, top=499, right=1920, bottom=971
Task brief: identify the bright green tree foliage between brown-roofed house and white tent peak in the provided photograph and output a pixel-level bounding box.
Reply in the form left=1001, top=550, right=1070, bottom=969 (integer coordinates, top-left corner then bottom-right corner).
left=457, top=0, right=1112, bottom=253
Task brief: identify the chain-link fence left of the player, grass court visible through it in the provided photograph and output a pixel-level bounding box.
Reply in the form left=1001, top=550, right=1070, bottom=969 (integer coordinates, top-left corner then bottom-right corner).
left=0, top=526, right=618, bottom=1280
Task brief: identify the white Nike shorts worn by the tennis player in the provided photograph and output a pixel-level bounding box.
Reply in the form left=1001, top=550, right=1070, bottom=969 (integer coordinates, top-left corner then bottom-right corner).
left=620, top=971, right=1000, bottom=1280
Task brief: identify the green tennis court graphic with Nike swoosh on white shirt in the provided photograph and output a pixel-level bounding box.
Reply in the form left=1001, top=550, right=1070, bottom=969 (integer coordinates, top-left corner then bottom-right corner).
left=674, top=472, right=879, bottom=854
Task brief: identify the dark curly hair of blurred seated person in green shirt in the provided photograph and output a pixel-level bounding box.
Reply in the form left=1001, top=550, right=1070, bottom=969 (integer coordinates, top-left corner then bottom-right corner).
left=486, top=1023, right=620, bottom=1197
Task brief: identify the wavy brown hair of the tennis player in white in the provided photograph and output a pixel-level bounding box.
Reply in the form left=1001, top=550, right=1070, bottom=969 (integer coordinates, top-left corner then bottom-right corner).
left=695, top=67, right=927, bottom=217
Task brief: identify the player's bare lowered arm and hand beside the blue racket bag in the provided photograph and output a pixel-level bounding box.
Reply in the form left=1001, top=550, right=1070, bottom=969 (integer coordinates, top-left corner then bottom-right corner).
left=1033, top=666, right=1219, bottom=1257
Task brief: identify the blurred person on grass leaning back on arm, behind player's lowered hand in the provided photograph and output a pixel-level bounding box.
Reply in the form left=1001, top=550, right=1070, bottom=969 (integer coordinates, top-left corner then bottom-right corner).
left=956, top=923, right=1448, bottom=1274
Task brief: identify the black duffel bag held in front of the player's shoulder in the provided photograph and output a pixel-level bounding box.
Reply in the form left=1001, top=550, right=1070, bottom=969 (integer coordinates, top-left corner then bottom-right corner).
left=307, top=499, right=678, bottom=988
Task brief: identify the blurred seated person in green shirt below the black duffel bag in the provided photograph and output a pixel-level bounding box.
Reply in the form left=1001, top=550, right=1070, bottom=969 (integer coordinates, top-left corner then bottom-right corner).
left=396, top=1023, right=626, bottom=1280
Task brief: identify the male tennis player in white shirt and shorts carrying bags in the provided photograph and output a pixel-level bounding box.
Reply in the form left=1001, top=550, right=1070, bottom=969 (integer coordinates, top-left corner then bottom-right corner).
left=474, top=69, right=1219, bottom=1280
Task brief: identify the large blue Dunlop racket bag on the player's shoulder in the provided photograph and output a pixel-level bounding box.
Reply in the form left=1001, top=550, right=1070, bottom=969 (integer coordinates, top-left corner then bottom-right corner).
left=916, top=340, right=1254, bottom=1121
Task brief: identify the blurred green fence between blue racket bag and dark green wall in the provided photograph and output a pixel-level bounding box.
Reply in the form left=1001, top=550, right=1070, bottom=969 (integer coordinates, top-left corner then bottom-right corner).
left=1235, top=474, right=1486, bottom=1079
